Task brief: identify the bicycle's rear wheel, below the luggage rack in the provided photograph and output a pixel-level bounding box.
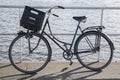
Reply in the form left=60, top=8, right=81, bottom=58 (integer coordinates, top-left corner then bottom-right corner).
left=74, top=31, right=113, bottom=71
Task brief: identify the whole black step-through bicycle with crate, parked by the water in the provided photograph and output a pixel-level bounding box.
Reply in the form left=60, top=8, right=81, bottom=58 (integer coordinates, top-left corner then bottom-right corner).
left=9, top=6, right=115, bottom=74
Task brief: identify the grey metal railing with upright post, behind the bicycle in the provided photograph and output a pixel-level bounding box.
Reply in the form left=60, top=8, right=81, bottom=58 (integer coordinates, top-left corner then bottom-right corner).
left=0, top=5, right=120, bottom=36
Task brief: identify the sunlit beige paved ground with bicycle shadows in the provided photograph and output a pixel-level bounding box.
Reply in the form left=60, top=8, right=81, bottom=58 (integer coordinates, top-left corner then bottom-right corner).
left=0, top=62, right=120, bottom=80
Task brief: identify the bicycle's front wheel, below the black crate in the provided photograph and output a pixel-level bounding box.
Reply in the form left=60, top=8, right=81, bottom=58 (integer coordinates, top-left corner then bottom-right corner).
left=9, top=33, right=52, bottom=74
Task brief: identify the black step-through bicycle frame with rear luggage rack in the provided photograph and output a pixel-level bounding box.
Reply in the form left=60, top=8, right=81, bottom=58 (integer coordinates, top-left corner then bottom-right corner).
left=41, top=12, right=104, bottom=53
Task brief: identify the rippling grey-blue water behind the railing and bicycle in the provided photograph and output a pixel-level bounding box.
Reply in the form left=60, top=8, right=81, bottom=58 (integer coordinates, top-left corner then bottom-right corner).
left=0, top=0, right=120, bottom=61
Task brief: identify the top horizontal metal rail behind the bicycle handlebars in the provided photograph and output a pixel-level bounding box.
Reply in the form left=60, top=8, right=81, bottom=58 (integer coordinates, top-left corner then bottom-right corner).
left=0, top=5, right=120, bottom=10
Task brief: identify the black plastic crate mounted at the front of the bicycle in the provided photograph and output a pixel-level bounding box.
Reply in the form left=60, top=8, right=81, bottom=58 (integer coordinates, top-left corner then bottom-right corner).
left=20, top=6, right=45, bottom=32
